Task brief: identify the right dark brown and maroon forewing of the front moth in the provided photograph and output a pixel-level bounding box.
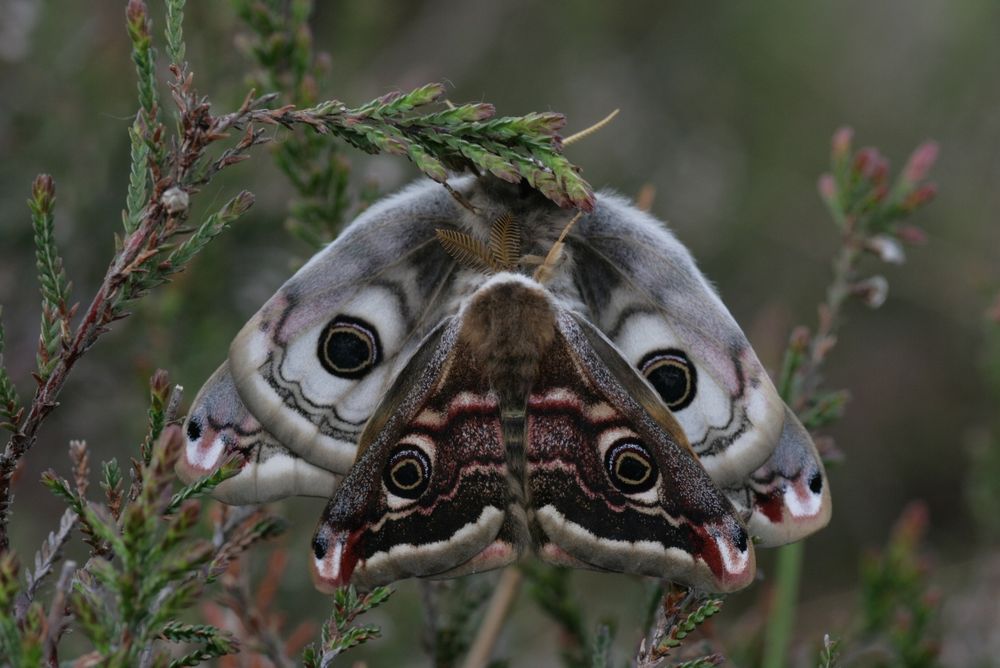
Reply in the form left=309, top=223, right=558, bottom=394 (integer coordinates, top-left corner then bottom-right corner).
left=526, top=310, right=755, bottom=591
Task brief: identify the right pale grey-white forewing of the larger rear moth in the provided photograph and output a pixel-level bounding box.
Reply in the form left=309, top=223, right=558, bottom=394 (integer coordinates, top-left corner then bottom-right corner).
left=569, top=201, right=783, bottom=485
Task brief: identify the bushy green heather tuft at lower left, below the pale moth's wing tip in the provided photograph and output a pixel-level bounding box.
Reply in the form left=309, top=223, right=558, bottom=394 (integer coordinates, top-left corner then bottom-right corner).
left=34, top=373, right=282, bottom=666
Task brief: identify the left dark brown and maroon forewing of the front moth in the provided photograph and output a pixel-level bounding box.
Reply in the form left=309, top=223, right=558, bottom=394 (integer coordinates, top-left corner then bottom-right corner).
left=312, top=294, right=527, bottom=591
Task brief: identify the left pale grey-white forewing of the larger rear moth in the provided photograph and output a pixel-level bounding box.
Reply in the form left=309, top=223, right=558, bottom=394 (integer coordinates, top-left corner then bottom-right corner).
left=229, top=184, right=455, bottom=473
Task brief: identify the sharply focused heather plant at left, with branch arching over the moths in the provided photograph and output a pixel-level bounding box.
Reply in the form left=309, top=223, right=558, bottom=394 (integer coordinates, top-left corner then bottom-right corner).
left=0, top=0, right=593, bottom=666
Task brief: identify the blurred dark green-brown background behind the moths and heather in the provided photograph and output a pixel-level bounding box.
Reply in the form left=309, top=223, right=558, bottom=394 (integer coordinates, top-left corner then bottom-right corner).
left=0, top=0, right=1000, bottom=665
